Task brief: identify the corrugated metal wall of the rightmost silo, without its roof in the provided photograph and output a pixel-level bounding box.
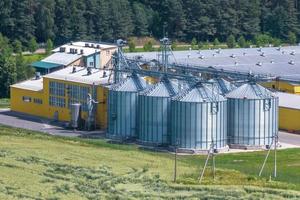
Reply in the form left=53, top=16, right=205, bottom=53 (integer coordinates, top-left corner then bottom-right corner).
left=228, top=98, right=278, bottom=146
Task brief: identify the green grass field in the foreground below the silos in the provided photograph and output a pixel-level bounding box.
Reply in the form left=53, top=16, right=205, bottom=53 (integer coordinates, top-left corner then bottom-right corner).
left=0, top=126, right=300, bottom=199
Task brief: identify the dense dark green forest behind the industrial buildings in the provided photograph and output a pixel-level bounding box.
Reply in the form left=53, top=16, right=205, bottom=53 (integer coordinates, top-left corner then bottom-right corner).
left=0, top=0, right=300, bottom=98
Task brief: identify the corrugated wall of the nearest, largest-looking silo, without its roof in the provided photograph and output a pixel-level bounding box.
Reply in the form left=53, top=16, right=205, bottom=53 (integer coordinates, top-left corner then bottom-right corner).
left=171, top=101, right=227, bottom=150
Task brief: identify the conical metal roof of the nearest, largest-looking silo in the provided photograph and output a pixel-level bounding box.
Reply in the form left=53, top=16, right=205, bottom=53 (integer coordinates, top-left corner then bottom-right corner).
left=174, top=83, right=226, bottom=103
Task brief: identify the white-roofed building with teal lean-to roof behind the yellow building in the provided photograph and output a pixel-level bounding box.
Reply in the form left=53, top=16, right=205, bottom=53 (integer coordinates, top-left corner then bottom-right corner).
left=31, top=42, right=117, bottom=74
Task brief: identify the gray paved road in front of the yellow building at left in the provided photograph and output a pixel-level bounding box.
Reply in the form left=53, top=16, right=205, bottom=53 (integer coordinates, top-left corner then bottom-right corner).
left=0, top=109, right=105, bottom=138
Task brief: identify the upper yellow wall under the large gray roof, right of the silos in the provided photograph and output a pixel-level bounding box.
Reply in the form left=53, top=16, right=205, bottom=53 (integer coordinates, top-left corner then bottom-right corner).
left=262, top=81, right=300, bottom=94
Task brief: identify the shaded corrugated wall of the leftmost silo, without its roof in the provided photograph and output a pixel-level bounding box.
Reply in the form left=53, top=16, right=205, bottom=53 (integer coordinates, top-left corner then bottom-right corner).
left=107, top=90, right=138, bottom=139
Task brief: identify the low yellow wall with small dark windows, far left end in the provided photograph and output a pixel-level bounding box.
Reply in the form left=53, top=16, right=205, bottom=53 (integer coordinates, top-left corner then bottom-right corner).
left=10, top=87, right=47, bottom=117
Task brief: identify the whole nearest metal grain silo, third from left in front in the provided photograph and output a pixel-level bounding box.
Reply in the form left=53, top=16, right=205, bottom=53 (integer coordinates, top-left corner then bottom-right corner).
left=171, top=83, right=227, bottom=150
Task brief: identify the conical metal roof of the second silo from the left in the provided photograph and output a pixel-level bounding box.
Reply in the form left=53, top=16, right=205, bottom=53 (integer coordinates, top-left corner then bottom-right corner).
left=141, top=78, right=178, bottom=97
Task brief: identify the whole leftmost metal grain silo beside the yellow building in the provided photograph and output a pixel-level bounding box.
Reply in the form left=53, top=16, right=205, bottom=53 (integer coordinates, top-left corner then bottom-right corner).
left=107, top=74, right=146, bottom=140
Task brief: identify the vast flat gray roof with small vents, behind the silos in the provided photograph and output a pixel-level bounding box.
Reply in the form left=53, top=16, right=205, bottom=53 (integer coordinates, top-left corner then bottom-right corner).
left=126, top=46, right=300, bottom=80
